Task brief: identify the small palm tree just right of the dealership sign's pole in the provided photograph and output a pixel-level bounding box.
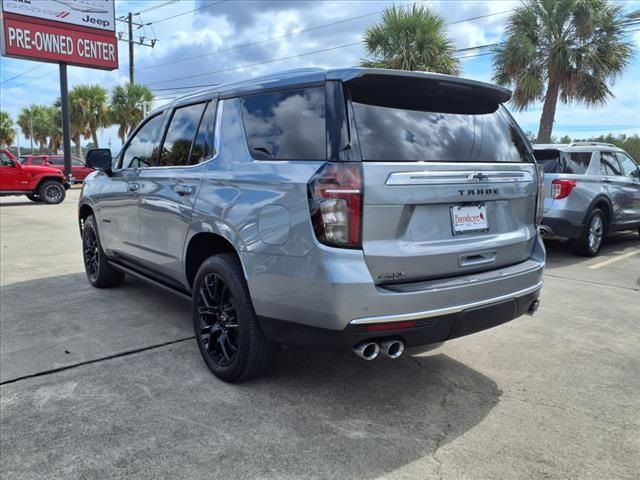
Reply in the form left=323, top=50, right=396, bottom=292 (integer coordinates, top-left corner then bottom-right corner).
left=69, top=85, right=111, bottom=148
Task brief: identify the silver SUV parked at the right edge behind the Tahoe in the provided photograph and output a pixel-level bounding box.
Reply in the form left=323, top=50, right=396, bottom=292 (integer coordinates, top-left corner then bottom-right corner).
left=534, top=142, right=640, bottom=256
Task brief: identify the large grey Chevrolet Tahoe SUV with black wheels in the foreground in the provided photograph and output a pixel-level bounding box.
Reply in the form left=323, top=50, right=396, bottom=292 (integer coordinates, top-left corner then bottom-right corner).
left=79, top=68, right=545, bottom=381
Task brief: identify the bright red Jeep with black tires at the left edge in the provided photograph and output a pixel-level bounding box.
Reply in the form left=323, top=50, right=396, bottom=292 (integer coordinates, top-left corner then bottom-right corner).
left=0, top=149, right=69, bottom=204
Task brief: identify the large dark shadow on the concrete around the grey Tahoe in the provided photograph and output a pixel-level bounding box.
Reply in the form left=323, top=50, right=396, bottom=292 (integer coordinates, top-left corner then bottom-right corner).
left=0, top=274, right=502, bottom=479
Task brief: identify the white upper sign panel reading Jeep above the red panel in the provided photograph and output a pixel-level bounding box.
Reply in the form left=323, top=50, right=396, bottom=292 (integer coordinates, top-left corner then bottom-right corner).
left=2, top=0, right=116, bottom=32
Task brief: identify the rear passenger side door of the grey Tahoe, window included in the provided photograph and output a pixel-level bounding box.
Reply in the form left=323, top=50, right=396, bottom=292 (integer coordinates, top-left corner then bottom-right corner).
left=139, top=101, right=216, bottom=280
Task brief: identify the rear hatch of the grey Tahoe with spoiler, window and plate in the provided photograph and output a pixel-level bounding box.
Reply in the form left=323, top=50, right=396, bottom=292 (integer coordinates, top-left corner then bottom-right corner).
left=345, top=73, right=538, bottom=284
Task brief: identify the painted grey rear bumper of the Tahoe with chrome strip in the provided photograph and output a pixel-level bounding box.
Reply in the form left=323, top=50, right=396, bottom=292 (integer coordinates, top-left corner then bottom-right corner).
left=248, top=237, right=545, bottom=343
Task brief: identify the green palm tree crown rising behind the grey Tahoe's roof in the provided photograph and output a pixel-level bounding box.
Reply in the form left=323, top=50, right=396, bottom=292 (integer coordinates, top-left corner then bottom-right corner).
left=362, top=4, right=460, bottom=75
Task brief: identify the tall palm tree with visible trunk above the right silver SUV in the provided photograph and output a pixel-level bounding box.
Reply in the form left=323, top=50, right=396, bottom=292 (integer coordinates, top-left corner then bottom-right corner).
left=493, top=0, right=633, bottom=143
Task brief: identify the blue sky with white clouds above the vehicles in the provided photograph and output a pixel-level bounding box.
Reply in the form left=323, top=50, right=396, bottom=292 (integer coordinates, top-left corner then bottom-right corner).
left=0, top=0, right=640, bottom=150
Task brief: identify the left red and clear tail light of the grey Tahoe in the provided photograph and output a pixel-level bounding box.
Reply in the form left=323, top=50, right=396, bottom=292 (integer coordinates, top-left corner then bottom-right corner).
left=309, top=163, right=362, bottom=248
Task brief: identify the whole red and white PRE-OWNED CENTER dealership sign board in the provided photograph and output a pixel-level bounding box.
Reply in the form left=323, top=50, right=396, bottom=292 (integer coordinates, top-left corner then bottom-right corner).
left=1, top=0, right=118, bottom=70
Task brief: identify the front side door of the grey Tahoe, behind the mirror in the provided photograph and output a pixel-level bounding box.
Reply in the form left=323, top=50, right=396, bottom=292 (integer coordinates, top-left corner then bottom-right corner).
left=98, top=112, right=164, bottom=261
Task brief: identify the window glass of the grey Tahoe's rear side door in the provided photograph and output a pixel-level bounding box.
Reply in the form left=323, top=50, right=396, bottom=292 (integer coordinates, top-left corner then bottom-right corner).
left=159, top=103, right=206, bottom=167
